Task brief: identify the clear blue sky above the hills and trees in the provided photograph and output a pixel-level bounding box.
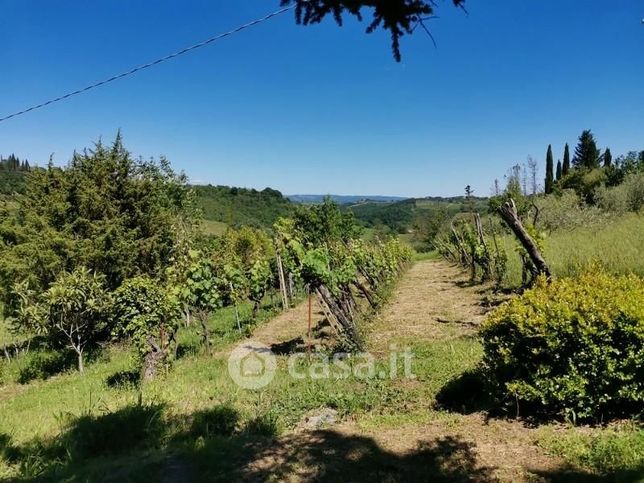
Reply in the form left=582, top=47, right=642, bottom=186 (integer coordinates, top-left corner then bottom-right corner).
left=0, top=0, right=644, bottom=196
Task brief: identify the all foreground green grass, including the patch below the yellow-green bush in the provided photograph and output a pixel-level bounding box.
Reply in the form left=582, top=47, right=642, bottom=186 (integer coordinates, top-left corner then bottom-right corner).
left=0, top=264, right=641, bottom=481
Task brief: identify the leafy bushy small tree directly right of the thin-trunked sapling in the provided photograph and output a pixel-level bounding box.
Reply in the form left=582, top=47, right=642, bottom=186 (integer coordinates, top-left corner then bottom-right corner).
left=112, top=276, right=181, bottom=379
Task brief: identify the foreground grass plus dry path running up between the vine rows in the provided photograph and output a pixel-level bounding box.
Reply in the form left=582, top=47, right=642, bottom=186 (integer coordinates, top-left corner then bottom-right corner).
left=0, top=261, right=644, bottom=481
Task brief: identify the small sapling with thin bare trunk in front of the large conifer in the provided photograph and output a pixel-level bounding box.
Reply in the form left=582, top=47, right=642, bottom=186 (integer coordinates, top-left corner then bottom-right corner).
left=40, top=267, right=110, bottom=372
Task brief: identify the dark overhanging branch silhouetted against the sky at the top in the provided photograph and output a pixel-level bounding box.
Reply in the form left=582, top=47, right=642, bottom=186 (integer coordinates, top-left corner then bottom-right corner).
left=281, top=0, right=465, bottom=62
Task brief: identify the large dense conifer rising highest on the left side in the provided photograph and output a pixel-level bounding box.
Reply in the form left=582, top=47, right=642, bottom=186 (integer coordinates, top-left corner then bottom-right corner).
left=0, top=135, right=192, bottom=312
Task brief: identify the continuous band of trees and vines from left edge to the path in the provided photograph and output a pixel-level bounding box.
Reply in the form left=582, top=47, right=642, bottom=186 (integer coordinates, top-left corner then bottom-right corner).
left=0, top=134, right=411, bottom=377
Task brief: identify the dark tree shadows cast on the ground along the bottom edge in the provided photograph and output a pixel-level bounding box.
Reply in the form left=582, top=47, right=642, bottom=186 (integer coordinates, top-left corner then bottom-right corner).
left=0, top=404, right=637, bottom=482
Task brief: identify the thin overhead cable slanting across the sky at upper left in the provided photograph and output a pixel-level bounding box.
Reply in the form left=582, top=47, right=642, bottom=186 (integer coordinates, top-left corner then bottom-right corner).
left=0, top=5, right=295, bottom=122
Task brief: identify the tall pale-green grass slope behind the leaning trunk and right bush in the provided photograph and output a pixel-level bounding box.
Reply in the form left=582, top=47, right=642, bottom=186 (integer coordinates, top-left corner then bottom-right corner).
left=503, top=213, right=644, bottom=287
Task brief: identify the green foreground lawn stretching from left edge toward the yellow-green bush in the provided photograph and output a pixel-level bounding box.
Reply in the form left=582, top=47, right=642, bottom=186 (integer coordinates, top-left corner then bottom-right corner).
left=0, top=298, right=481, bottom=479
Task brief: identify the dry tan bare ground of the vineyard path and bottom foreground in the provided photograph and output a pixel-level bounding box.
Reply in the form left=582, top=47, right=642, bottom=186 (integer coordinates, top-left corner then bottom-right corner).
left=235, top=261, right=561, bottom=482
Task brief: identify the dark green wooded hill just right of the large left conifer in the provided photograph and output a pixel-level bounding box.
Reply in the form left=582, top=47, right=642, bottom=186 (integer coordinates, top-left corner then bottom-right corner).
left=192, top=185, right=294, bottom=230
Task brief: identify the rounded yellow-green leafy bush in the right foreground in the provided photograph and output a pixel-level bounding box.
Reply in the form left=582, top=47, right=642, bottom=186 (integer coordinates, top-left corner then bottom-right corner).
left=481, top=269, right=644, bottom=420
